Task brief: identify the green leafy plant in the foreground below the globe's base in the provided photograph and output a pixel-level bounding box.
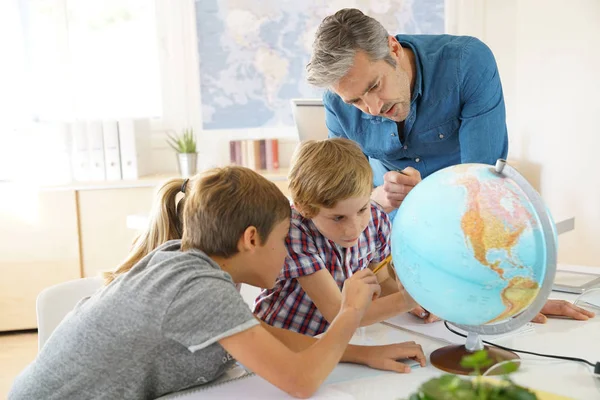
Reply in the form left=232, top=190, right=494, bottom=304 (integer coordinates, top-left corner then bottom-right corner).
left=408, top=350, right=538, bottom=400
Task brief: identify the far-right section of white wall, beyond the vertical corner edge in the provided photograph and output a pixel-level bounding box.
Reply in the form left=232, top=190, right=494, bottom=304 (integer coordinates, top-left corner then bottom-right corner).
left=511, top=0, right=600, bottom=265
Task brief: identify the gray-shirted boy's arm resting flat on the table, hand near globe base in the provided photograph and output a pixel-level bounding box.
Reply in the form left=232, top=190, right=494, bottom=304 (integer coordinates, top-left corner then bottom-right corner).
left=259, top=320, right=426, bottom=372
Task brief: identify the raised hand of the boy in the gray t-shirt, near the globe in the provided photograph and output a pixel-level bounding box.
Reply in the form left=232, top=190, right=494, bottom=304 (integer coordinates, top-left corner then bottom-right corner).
left=341, top=269, right=381, bottom=318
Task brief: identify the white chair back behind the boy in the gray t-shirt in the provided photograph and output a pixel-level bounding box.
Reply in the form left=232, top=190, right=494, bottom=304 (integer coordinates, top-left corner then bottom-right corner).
left=36, top=277, right=103, bottom=351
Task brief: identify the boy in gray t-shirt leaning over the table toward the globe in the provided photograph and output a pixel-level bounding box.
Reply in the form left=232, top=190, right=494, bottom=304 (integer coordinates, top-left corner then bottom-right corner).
left=9, top=167, right=425, bottom=400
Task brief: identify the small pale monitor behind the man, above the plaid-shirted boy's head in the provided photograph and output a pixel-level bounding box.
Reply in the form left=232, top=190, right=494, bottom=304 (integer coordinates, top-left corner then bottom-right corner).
left=292, top=99, right=328, bottom=142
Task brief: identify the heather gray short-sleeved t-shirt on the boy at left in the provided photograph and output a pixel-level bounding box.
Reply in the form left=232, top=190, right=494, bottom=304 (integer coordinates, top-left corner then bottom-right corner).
left=8, top=241, right=258, bottom=400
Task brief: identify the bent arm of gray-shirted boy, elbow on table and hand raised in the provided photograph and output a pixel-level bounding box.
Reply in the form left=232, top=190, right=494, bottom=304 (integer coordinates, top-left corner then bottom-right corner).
left=219, top=271, right=379, bottom=398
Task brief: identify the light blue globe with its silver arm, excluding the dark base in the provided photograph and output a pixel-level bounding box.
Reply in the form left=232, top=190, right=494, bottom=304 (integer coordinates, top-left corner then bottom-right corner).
left=391, top=160, right=556, bottom=376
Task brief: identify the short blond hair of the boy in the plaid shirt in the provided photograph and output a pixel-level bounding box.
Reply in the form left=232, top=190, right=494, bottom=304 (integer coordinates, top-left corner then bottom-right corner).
left=288, top=138, right=373, bottom=218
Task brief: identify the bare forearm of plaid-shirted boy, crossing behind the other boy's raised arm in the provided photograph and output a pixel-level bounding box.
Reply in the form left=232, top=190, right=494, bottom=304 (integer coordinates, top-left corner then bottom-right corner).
left=297, top=269, right=417, bottom=326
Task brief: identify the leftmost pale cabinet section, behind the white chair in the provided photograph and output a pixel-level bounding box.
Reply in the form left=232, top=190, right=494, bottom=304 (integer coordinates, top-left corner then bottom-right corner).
left=0, top=190, right=81, bottom=331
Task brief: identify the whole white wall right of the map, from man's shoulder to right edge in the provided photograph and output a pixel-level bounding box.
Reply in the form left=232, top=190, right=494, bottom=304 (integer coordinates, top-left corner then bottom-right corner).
left=449, top=0, right=600, bottom=265
